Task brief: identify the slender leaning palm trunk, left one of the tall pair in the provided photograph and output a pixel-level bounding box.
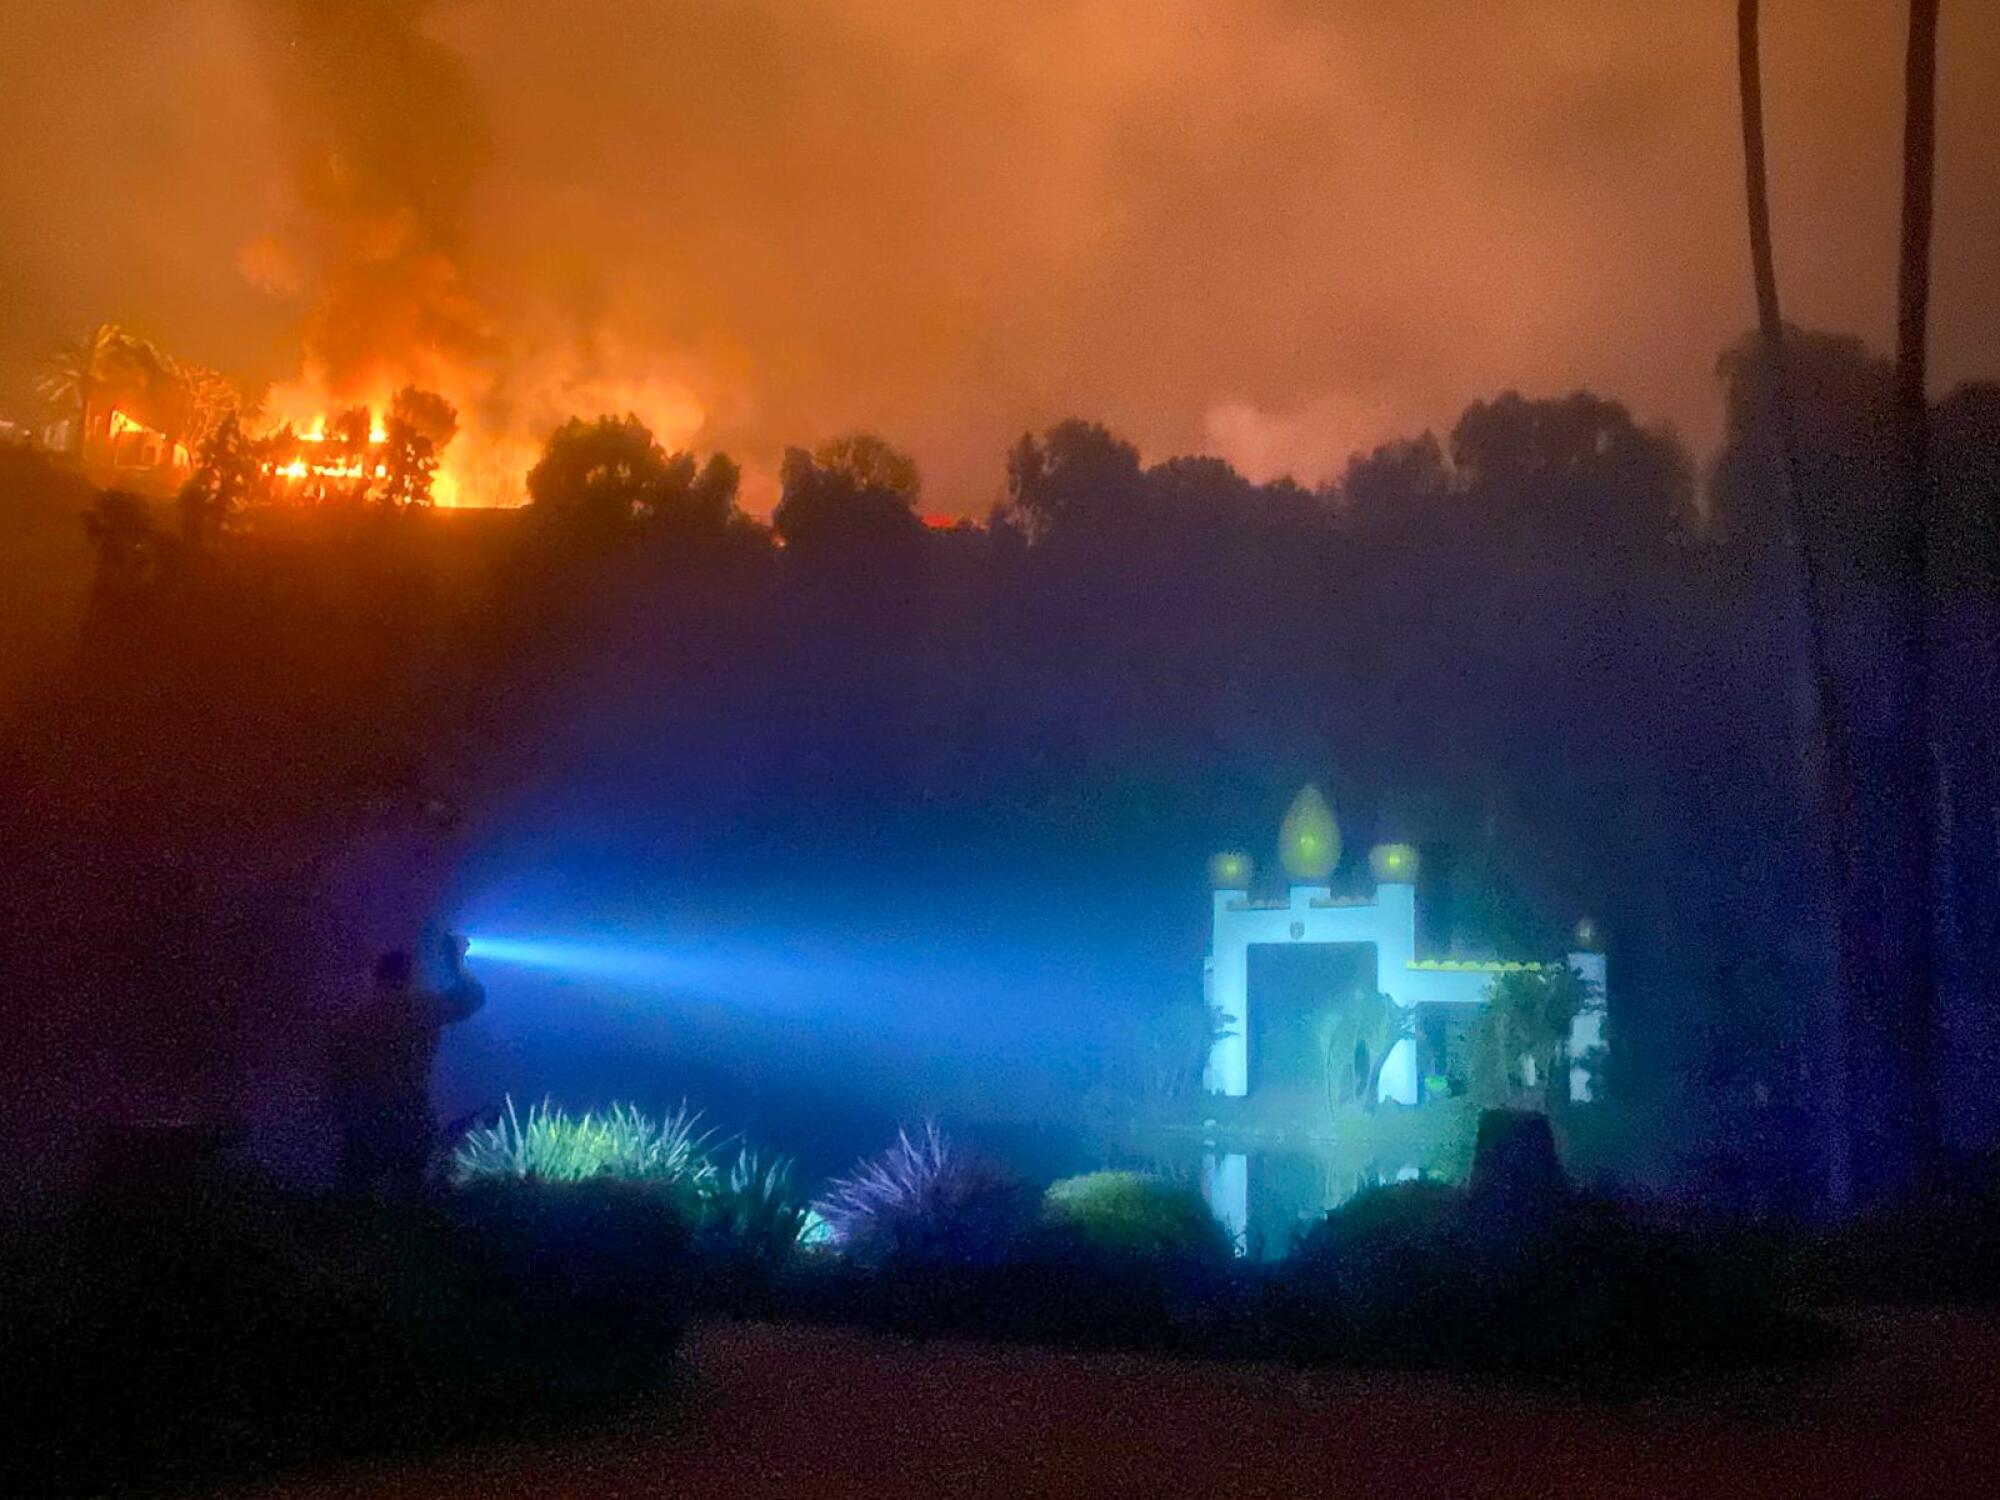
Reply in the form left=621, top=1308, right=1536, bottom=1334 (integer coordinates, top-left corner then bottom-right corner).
left=1736, top=0, right=1858, bottom=1206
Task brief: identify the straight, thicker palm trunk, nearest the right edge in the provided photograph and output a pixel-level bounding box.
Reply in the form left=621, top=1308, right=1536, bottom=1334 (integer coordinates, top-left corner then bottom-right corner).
left=1886, top=0, right=1940, bottom=1190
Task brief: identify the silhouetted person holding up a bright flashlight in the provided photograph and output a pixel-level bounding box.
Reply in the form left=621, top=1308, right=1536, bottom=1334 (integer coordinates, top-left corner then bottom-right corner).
left=326, top=936, right=486, bottom=1192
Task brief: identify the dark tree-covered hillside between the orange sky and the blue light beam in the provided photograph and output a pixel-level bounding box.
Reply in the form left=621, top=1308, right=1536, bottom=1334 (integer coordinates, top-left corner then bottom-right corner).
left=10, top=324, right=2000, bottom=1208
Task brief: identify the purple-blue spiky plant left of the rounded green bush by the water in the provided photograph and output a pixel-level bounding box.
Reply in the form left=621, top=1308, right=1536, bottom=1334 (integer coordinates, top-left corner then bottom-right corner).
left=814, top=1122, right=1034, bottom=1264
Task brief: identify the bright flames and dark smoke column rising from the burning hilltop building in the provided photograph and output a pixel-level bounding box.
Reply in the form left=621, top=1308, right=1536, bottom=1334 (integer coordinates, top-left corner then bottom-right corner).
left=229, top=0, right=710, bottom=506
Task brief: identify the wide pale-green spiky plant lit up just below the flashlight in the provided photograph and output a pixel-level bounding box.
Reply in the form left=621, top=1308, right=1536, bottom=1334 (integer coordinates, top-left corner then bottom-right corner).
left=450, top=1096, right=716, bottom=1194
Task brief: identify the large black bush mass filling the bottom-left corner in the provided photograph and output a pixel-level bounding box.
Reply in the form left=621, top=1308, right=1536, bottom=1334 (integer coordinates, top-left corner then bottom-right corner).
left=0, top=1178, right=682, bottom=1494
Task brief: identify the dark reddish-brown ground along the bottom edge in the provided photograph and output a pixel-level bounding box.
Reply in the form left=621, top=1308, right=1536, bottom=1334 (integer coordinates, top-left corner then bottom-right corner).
left=232, top=1310, right=2000, bottom=1500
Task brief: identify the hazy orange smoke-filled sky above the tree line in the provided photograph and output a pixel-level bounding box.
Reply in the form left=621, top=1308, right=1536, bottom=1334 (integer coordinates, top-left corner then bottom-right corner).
left=0, top=0, right=2000, bottom=512
